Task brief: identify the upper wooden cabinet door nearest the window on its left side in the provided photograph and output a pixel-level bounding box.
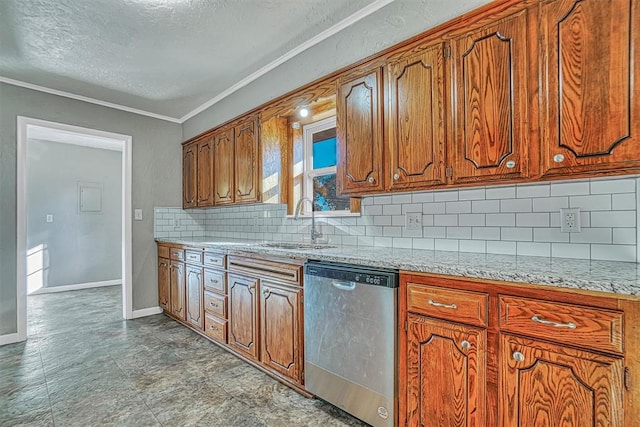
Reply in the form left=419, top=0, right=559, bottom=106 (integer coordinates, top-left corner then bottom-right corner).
left=234, top=119, right=259, bottom=202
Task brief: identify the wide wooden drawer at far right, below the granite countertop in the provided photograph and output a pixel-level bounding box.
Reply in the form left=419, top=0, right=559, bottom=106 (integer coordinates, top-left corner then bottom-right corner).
left=500, top=296, right=623, bottom=353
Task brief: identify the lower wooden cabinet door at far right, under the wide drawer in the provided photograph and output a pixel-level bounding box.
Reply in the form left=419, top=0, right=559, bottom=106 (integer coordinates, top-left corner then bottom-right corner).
left=498, top=334, right=623, bottom=427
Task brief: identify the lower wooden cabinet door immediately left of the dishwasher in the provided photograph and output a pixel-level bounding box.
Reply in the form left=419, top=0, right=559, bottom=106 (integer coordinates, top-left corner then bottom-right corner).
left=260, top=280, right=304, bottom=384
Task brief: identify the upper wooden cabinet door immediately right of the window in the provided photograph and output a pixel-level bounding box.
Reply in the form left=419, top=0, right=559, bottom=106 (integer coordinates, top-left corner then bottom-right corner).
left=336, top=68, right=384, bottom=195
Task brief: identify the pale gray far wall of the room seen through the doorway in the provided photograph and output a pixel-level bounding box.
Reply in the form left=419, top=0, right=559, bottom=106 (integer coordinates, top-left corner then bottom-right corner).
left=27, top=139, right=122, bottom=288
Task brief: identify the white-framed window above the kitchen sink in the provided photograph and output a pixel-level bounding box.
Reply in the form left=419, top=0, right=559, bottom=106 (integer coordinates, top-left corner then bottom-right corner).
left=303, top=117, right=351, bottom=216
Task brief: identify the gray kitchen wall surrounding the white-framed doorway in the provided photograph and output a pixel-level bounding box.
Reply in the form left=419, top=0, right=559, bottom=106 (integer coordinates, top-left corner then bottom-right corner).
left=0, top=83, right=182, bottom=335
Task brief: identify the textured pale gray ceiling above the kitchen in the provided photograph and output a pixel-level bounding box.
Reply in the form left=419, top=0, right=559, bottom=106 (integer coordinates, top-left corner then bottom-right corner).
left=0, top=0, right=380, bottom=118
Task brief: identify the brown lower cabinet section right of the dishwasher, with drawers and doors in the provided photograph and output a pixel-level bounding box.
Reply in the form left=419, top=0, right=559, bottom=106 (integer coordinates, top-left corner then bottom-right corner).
left=399, top=273, right=640, bottom=427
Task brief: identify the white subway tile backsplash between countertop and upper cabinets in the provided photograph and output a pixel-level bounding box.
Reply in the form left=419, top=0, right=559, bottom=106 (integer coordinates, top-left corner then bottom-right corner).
left=154, top=177, right=640, bottom=261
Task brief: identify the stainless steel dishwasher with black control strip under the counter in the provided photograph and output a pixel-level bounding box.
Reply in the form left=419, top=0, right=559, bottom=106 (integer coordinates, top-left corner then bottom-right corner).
left=304, top=261, right=398, bottom=427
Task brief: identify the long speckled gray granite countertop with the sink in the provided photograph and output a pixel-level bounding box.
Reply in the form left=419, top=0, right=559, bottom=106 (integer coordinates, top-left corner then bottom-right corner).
left=156, top=238, right=640, bottom=297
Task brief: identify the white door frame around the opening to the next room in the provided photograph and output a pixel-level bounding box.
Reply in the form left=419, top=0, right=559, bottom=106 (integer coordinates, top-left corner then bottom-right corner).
left=16, top=116, right=134, bottom=341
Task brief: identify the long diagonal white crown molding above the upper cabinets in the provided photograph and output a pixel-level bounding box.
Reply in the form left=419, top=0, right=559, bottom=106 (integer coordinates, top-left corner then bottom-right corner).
left=180, top=0, right=394, bottom=123
